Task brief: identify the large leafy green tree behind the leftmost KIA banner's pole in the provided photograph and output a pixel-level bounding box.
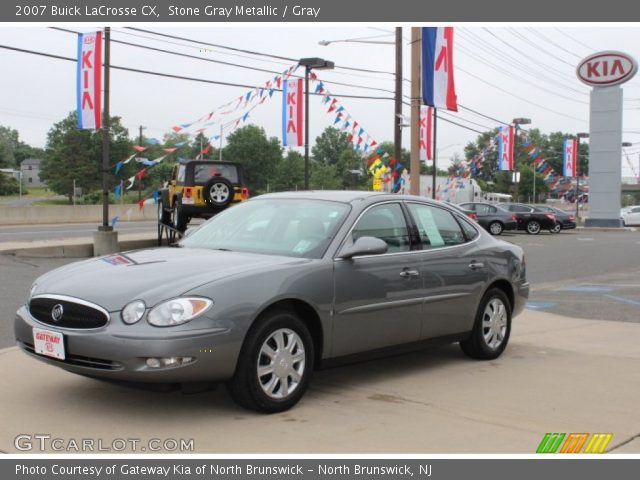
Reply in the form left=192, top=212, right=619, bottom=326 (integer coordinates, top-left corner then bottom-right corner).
left=40, top=111, right=131, bottom=203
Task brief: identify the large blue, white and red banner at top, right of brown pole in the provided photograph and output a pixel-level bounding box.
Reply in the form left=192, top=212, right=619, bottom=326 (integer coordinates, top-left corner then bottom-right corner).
left=422, top=27, right=458, bottom=112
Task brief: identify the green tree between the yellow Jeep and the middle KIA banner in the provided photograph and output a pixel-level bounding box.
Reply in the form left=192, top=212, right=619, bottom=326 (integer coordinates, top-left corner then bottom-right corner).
left=222, top=125, right=282, bottom=194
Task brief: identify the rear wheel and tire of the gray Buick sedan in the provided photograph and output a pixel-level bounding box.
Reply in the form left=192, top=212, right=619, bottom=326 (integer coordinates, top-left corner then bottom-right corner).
left=460, top=288, right=511, bottom=360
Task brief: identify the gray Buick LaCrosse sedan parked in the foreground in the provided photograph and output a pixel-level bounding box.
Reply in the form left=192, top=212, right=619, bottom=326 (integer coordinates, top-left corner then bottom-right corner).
left=15, top=192, right=529, bottom=412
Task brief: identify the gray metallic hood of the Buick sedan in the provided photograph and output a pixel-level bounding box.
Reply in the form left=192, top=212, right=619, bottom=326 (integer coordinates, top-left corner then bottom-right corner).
left=33, top=248, right=309, bottom=312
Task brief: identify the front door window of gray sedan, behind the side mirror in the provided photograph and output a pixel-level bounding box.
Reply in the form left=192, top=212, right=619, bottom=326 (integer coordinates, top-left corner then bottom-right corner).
left=351, top=203, right=411, bottom=253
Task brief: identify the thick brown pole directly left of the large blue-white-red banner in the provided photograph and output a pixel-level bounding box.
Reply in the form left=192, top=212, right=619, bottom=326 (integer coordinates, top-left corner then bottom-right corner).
left=409, top=27, right=422, bottom=195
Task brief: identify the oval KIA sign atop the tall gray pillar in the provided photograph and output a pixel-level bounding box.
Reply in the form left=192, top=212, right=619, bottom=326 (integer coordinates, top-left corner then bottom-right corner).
left=576, top=51, right=638, bottom=87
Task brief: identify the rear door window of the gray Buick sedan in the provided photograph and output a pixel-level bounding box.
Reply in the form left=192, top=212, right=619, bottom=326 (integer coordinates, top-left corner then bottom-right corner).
left=409, top=203, right=465, bottom=248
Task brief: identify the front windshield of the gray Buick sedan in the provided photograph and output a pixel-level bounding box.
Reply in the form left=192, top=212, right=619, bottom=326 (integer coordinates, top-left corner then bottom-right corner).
left=179, top=198, right=350, bottom=258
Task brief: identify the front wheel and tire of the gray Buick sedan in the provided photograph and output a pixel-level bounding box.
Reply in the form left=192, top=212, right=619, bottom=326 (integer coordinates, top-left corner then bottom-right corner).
left=227, top=310, right=314, bottom=413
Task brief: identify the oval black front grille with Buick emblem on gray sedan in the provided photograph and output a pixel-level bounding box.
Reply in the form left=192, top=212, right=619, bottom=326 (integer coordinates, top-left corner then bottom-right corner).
left=29, top=296, right=109, bottom=329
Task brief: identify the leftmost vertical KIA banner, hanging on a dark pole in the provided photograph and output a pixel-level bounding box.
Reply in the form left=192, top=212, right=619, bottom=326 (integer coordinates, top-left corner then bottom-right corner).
left=76, top=32, right=102, bottom=129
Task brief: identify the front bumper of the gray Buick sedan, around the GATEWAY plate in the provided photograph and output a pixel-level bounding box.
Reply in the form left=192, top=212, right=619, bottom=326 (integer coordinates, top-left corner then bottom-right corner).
left=14, top=307, right=241, bottom=383
